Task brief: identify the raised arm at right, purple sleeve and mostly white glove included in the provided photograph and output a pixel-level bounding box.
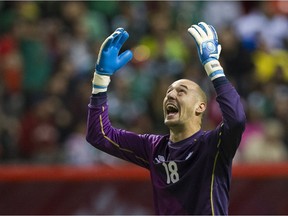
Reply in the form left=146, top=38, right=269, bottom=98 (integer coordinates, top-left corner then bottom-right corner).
left=188, top=22, right=246, bottom=159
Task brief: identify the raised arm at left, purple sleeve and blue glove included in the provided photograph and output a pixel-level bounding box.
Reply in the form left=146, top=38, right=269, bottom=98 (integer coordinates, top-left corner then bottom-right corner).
left=86, top=28, right=155, bottom=168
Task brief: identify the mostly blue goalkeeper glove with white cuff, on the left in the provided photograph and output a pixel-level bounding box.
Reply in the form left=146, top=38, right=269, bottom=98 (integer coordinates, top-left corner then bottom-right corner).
left=92, top=28, right=133, bottom=94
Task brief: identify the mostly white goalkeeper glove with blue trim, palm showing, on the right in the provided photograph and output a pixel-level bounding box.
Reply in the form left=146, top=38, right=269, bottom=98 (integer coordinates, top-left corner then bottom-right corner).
left=188, top=22, right=225, bottom=80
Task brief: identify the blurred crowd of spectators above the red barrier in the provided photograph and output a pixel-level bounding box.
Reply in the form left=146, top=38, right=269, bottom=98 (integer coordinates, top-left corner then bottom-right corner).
left=0, top=1, right=288, bottom=165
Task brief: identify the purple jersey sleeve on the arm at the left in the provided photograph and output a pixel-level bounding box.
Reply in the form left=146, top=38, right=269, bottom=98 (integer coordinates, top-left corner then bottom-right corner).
left=86, top=93, right=161, bottom=168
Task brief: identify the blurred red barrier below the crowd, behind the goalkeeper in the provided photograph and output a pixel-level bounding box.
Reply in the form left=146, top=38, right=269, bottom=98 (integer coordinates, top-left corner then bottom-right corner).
left=0, top=163, right=288, bottom=215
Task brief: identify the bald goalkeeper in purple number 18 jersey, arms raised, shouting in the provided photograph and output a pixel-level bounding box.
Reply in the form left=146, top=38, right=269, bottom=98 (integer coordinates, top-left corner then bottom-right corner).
left=86, top=22, right=246, bottom=215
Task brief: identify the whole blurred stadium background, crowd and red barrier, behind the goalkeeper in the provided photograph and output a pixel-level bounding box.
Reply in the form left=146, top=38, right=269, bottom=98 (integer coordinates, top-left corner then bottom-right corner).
left=0, top=1, right=288, bottom=214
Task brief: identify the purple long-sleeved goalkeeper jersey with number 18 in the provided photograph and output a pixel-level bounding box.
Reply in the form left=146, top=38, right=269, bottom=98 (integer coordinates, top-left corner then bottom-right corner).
left=87, top=79, right=246, bottom=215
